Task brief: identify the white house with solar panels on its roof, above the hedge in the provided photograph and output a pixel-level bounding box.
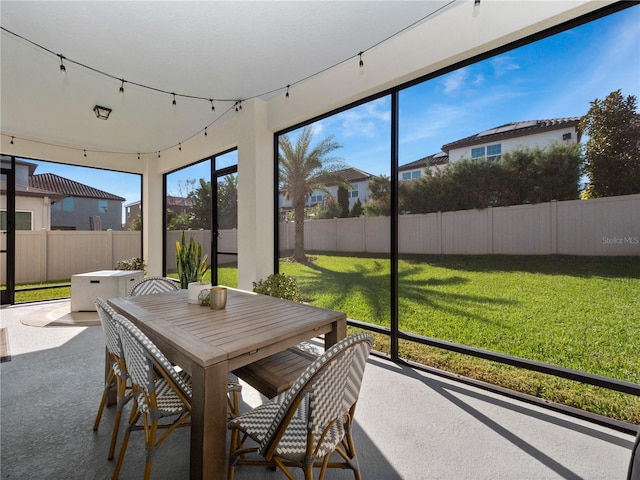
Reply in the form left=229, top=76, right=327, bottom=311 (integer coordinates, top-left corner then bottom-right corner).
left=398, top=117, right=581, bottom=180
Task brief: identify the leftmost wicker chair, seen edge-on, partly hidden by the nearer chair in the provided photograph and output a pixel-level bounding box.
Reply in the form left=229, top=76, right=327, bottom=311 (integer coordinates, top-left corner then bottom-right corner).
left=93, top=298, right=131, bottom=460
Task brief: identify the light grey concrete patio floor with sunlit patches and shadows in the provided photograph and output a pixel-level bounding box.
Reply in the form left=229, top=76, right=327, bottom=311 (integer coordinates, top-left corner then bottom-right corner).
left=0, top=304, right=634, bottom=480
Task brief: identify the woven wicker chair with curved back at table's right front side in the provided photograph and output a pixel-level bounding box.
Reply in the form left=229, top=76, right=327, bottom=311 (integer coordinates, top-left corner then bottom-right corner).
left=228, top=333, right=373, bottom=480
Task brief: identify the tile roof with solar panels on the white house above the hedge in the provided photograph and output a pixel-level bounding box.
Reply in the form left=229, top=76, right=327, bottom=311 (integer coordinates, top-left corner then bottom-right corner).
left=442, top=117, right=581, bottom=152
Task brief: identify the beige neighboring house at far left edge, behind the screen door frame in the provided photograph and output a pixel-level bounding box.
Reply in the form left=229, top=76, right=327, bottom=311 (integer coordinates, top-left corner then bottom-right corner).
left=0, top=157, right=63, bottom=230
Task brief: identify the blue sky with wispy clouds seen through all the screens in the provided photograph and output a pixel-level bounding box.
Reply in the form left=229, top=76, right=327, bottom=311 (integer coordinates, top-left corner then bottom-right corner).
left=22, top=6, right=640, bottom=219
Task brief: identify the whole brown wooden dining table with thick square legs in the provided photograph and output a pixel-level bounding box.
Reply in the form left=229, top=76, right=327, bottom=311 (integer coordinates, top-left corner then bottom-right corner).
left=108, top=288, right=347, bottom=479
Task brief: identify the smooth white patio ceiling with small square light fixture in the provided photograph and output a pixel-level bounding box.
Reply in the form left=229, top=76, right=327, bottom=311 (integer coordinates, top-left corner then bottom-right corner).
left=0, top=0, right=458, bottom=157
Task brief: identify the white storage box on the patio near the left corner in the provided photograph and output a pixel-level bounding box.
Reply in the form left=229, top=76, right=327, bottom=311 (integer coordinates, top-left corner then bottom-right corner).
left=71, top=270, right=144, bottom=312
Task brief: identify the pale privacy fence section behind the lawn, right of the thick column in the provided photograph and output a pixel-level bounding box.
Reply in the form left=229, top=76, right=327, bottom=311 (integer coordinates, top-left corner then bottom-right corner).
left=279, top=194, right=640, bottom=256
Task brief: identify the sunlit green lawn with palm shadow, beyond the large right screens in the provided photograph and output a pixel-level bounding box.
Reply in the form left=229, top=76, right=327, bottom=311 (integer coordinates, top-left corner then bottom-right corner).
left=281, top=254, right=640, bottom=423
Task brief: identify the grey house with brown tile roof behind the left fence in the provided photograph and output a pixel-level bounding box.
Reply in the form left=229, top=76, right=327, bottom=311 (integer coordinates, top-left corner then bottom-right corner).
left=29, top=173, right=125, bottom=230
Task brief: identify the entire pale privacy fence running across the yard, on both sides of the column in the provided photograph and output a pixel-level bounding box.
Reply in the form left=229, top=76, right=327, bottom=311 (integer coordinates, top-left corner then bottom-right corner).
left=6, top=194, right=640, bottom=283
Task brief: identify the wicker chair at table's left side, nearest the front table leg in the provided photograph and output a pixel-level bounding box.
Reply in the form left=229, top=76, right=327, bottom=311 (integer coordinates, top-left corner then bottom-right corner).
left=113, top=314, right=241, bottom=480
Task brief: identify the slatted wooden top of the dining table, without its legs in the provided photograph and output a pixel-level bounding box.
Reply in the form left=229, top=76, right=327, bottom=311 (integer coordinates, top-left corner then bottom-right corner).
left=109, top=289, right=345, bottom=366
